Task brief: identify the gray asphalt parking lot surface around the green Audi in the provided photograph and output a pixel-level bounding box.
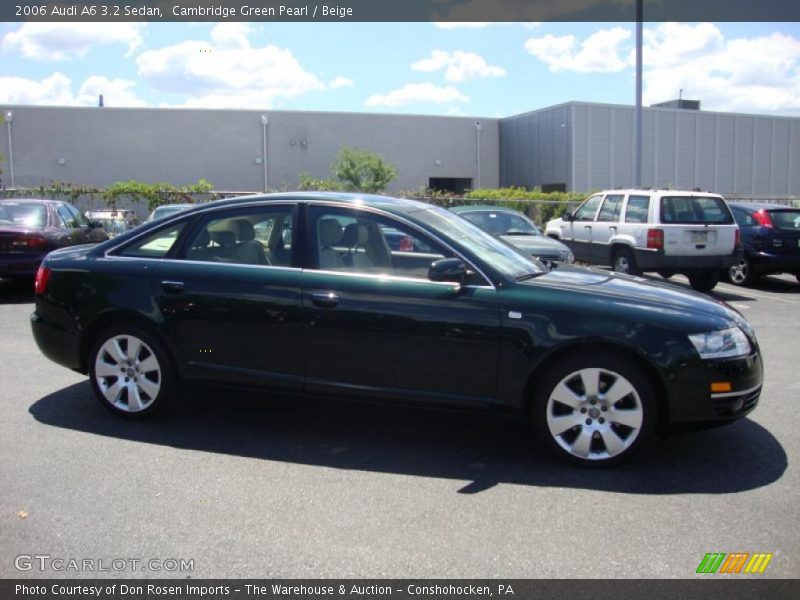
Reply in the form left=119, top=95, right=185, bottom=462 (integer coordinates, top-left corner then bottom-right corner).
left=0, top=276, right=800, bottom=578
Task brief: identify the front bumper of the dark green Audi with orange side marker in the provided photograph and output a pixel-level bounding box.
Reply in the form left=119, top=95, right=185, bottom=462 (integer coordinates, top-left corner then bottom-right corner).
left=669, top=350, right=764, bottom=427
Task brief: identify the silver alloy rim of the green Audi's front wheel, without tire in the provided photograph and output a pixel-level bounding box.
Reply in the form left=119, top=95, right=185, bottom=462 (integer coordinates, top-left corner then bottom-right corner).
left=544, top=367, right=645, bottom=463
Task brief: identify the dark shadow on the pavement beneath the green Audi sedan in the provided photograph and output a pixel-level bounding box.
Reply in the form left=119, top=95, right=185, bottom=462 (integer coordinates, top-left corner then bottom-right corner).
left=29, top=382, right=787, bottom=494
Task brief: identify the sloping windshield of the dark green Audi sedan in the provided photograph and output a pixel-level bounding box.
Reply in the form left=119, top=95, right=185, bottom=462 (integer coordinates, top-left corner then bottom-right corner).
left=414, top=206, right=546, bottom=279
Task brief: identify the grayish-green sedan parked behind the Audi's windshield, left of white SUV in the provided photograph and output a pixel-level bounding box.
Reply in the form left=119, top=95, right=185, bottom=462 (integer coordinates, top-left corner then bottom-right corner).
left=450, top=206, right=575, bottom=269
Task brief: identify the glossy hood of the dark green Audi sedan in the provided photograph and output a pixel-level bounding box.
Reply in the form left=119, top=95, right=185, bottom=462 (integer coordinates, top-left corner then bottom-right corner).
left=518, top=266, right=753, bottom=336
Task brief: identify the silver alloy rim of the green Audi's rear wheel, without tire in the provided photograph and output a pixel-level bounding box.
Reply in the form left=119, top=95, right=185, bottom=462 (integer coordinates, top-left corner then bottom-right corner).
left=94, top=335, right=162, bottom=413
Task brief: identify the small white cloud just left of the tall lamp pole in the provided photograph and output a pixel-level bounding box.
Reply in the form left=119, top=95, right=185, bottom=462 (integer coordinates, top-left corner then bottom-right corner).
left=525, top=27, right=631, bottom=73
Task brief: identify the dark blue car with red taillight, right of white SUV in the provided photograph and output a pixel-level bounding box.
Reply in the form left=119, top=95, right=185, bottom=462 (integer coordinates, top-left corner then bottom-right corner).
left=725, top=202, right=800, bottom=285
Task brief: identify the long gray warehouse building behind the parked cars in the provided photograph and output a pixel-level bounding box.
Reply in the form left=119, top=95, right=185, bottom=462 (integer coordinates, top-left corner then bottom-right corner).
left=0, top=101, right=800, bottom=198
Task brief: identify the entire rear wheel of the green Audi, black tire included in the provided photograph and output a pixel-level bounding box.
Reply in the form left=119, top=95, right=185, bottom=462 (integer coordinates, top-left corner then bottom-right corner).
left=89, top=323, right=177, bottom=419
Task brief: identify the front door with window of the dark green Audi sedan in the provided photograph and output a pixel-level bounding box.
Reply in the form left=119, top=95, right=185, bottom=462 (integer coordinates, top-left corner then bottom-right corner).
left=303, top=206, right=500, bottom=404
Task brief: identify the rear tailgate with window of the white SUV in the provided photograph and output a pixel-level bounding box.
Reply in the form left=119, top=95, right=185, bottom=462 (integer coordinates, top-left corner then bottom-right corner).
left=659, top=194, right=738, bottom=256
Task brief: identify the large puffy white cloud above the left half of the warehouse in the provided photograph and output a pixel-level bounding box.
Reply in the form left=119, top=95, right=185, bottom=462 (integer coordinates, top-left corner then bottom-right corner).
left=136, top=23, right=327, bottom=108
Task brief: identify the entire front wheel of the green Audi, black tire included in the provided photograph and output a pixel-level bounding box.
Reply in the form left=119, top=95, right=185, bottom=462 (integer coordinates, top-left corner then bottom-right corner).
left=531, top=352, right=657, bottom=468
